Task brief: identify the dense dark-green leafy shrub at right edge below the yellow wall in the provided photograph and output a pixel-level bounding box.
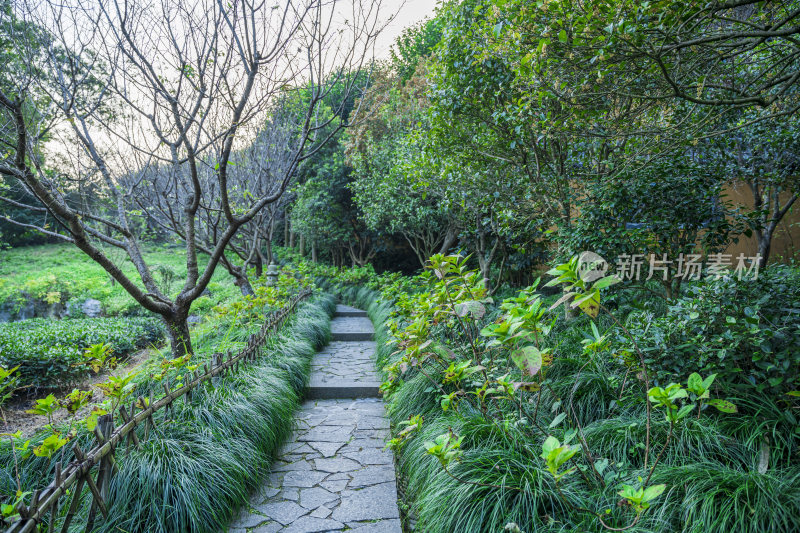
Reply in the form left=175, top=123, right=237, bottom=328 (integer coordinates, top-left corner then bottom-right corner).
left=627, top=267, right=800, bottom=399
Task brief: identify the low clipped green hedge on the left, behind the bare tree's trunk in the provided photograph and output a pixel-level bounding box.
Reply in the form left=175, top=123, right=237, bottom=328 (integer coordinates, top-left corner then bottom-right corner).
left=0, top=317, right=164, bottom=388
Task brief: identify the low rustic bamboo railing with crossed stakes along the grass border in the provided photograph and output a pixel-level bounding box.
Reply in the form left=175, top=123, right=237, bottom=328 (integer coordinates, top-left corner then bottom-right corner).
left=5, top=289, right=311, bottom=533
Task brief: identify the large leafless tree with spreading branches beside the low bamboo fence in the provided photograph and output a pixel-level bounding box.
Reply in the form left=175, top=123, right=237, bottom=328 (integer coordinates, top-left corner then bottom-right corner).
left=0, top=0, right=388, bottom=355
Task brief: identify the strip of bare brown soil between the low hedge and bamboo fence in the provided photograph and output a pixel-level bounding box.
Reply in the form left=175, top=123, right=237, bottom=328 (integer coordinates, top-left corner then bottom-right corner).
left=2, top=349, right=152, bottom=437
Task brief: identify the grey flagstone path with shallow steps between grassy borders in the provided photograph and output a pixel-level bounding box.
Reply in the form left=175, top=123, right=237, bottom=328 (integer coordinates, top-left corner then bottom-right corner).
left=229, top=306, right=402, bottom=533
